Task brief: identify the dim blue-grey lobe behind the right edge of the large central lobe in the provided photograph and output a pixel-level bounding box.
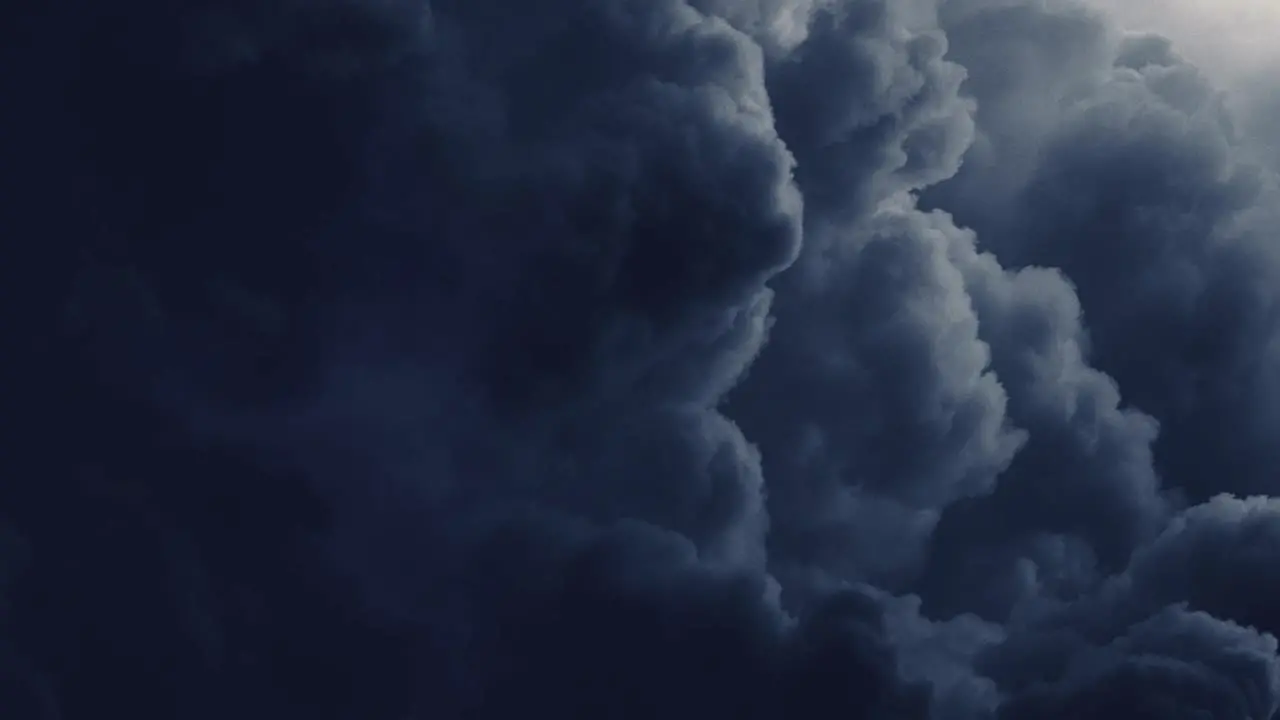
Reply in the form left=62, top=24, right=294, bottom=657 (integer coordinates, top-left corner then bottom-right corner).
left=925, top=215, right=1169, bottom=615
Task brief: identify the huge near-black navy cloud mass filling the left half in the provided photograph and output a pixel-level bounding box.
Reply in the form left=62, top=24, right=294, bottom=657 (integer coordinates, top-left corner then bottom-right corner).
left=5, top=1, right=936, bottom=717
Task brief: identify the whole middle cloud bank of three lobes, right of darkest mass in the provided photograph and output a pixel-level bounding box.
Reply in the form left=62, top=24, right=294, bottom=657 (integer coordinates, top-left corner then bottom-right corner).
left=730, top=3, right=1166, bottom=615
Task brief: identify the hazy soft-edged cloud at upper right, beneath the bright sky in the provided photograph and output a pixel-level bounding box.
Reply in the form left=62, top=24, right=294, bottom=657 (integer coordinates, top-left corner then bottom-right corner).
left=931, top=0, right=1276, bottom=500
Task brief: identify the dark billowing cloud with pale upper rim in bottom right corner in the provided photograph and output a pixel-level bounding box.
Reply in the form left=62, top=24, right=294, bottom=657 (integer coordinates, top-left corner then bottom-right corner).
left=980, top=496, right=1280, bottom=717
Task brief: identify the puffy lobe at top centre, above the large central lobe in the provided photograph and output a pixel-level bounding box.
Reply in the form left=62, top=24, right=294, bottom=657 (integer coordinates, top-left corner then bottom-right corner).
left=768, top=1, right=973, bottom=224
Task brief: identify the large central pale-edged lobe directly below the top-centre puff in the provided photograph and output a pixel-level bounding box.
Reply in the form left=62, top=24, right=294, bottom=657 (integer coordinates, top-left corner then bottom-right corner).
left=730, top=194, right=1025, bottom=580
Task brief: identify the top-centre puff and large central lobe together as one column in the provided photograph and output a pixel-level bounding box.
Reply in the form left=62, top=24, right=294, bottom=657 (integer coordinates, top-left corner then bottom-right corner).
left=728, top=3, right=1020, bottom=582
